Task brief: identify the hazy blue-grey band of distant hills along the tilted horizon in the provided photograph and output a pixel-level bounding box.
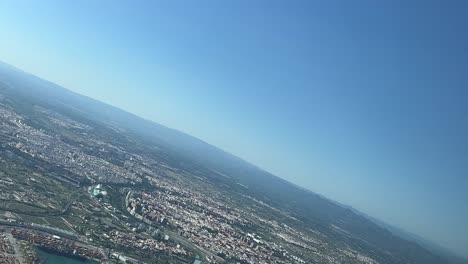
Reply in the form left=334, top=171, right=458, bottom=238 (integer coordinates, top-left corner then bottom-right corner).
left=0, top=60, right=468, bottom=264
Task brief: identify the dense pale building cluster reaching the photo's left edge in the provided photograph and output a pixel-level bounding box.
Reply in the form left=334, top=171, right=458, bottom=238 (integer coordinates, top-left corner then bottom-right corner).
left=0, top=105, right=140, bottom=184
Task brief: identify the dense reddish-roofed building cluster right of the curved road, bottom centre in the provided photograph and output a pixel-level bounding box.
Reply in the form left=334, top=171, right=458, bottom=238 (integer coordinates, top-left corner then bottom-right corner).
left=126, top=179, right=292, bottom=263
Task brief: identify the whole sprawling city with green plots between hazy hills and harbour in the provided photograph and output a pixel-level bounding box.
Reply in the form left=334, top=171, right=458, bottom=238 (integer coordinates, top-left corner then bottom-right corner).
left=0, top=73, right=394, bottom=264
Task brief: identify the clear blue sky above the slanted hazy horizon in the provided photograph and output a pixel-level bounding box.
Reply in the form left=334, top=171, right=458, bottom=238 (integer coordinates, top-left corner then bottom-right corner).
left=0, top=0, right=468, bottom=257
